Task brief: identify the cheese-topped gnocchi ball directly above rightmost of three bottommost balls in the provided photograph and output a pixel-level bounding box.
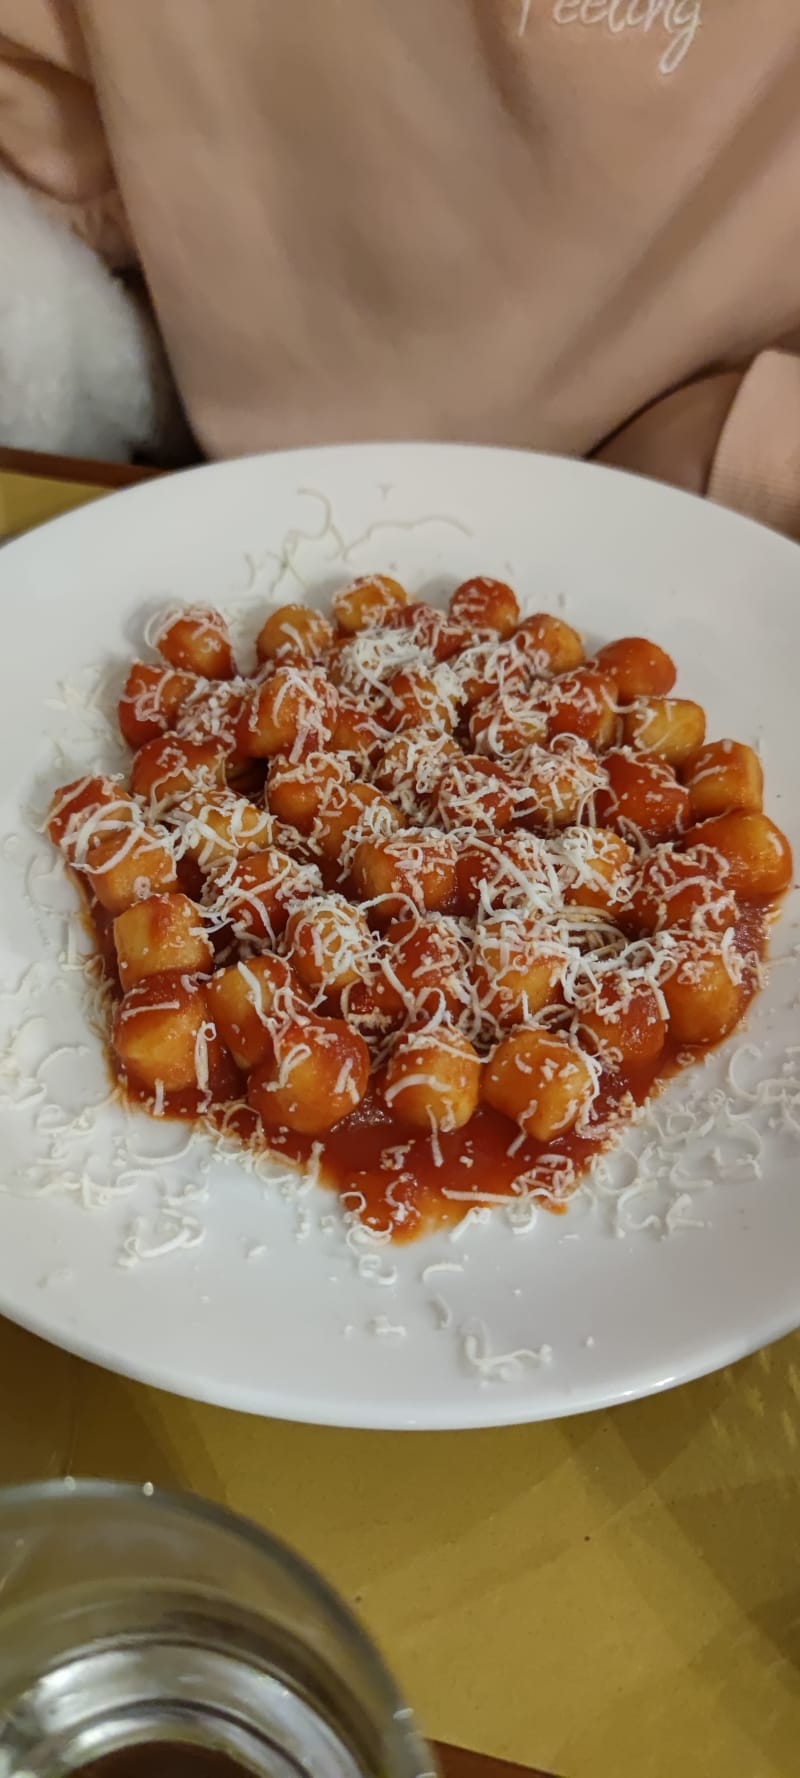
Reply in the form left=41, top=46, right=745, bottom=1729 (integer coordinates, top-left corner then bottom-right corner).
left=468, top=910, right=567, bottom=1028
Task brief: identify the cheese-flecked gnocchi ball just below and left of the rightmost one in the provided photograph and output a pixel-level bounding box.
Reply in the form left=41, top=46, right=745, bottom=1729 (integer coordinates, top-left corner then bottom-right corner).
left=624, top=846, right=738, bottom=933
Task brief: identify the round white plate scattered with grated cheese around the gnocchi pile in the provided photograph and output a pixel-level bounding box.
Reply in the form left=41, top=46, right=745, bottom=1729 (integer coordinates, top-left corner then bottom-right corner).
left=0, top=446, right=800, bottom=1428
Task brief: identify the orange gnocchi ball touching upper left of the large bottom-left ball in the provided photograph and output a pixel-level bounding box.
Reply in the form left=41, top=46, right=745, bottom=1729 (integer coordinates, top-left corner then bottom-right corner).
left=204, top=953, right=306, bottom=1074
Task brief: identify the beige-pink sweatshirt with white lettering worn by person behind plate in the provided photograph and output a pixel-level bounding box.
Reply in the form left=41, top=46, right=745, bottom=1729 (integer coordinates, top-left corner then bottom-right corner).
left=0, top=0, right=800, bottom=535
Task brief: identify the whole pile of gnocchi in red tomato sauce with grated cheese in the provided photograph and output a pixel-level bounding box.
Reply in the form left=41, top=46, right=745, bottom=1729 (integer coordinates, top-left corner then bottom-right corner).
left=46, top=574, right=793, bottom=1234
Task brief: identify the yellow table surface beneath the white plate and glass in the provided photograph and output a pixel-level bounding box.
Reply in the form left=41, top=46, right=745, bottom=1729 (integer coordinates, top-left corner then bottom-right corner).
left=0, top=452, right=800, bottom=1778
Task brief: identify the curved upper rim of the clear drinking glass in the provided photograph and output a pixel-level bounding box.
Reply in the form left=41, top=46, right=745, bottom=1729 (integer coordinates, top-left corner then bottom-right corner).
left=0, top=1478, right=418, bottom=1735
